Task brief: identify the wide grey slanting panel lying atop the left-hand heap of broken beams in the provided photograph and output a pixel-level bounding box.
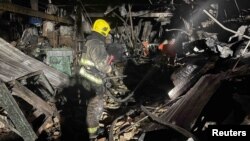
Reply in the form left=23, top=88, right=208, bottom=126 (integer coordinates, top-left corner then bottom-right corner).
left=0, top=38, right=69, bottom=88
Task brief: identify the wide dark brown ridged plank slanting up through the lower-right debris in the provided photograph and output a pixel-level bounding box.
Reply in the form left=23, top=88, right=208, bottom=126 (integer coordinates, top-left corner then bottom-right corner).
left=146, top=73, right=225, bottom=131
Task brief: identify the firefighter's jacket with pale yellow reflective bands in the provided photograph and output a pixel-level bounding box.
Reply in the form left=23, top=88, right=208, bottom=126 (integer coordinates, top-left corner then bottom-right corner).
left=79, top=32, right=111, bottom=85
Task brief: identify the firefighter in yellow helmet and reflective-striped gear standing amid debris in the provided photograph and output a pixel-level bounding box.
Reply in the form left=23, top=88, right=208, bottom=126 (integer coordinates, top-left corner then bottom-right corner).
left=79, top=19, right=113, bottom=138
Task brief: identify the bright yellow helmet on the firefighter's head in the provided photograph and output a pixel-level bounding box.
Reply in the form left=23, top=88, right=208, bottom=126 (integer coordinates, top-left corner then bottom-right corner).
left=92, top=19, right=110, bottom=37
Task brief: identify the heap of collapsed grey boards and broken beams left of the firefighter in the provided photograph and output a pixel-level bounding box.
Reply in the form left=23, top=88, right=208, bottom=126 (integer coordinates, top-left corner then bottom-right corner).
left=0, top=39, right=68, bottom=140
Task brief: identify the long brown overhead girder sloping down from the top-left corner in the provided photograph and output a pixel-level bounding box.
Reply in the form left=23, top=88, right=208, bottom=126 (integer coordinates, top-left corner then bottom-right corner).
left=0, top=3, right=73, bottom=24
